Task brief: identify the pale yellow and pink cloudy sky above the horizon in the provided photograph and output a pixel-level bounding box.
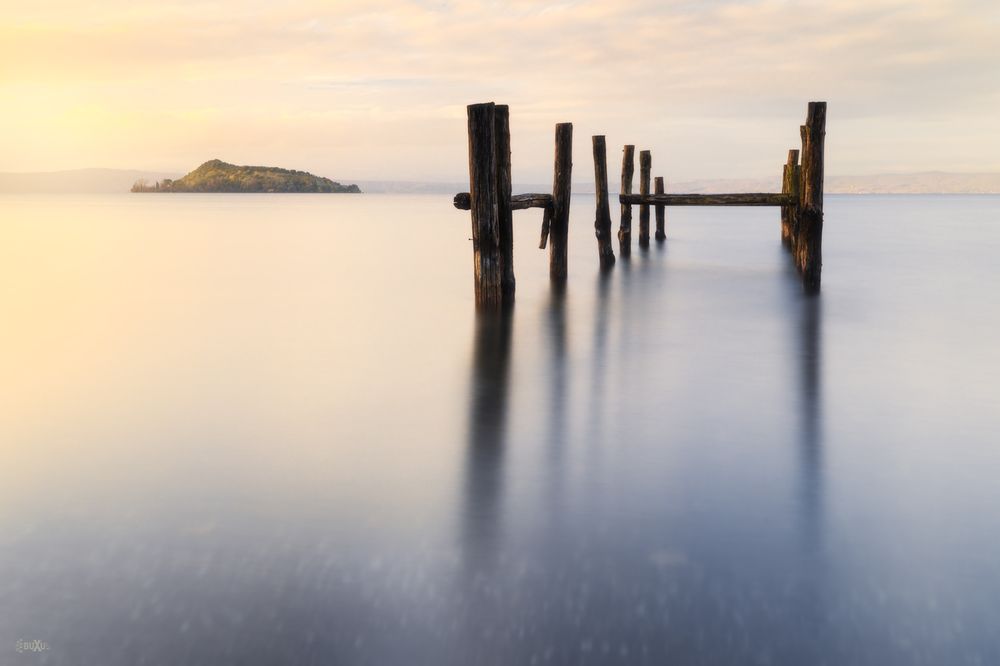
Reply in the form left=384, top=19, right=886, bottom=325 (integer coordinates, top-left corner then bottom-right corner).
left=0, top=0, right=1000, bottom=182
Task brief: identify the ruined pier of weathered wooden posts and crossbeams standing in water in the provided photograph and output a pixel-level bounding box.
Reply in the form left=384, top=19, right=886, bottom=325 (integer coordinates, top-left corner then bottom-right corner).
left=454, top=102, right=826, bottom=308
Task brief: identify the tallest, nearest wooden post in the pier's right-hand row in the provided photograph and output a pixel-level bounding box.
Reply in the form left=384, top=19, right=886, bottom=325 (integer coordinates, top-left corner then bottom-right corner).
left=795, top=102, right=826, bottom=293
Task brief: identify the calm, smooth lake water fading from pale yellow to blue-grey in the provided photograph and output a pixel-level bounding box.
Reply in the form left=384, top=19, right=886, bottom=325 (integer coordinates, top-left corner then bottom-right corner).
left=0, top=195, right=1000, bottom=666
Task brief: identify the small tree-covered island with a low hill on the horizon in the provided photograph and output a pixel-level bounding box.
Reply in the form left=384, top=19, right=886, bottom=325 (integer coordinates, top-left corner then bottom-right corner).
left=132, top=160, right=361, bottom=193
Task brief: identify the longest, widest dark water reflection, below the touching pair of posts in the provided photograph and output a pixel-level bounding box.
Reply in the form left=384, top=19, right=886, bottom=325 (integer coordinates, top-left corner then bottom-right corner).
left=463, top=308, right=513, bottom=562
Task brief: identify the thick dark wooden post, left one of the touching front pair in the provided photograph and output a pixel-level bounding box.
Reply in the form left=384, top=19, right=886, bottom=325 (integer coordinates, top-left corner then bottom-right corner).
left=467, top=102, right=503, bottom=309
